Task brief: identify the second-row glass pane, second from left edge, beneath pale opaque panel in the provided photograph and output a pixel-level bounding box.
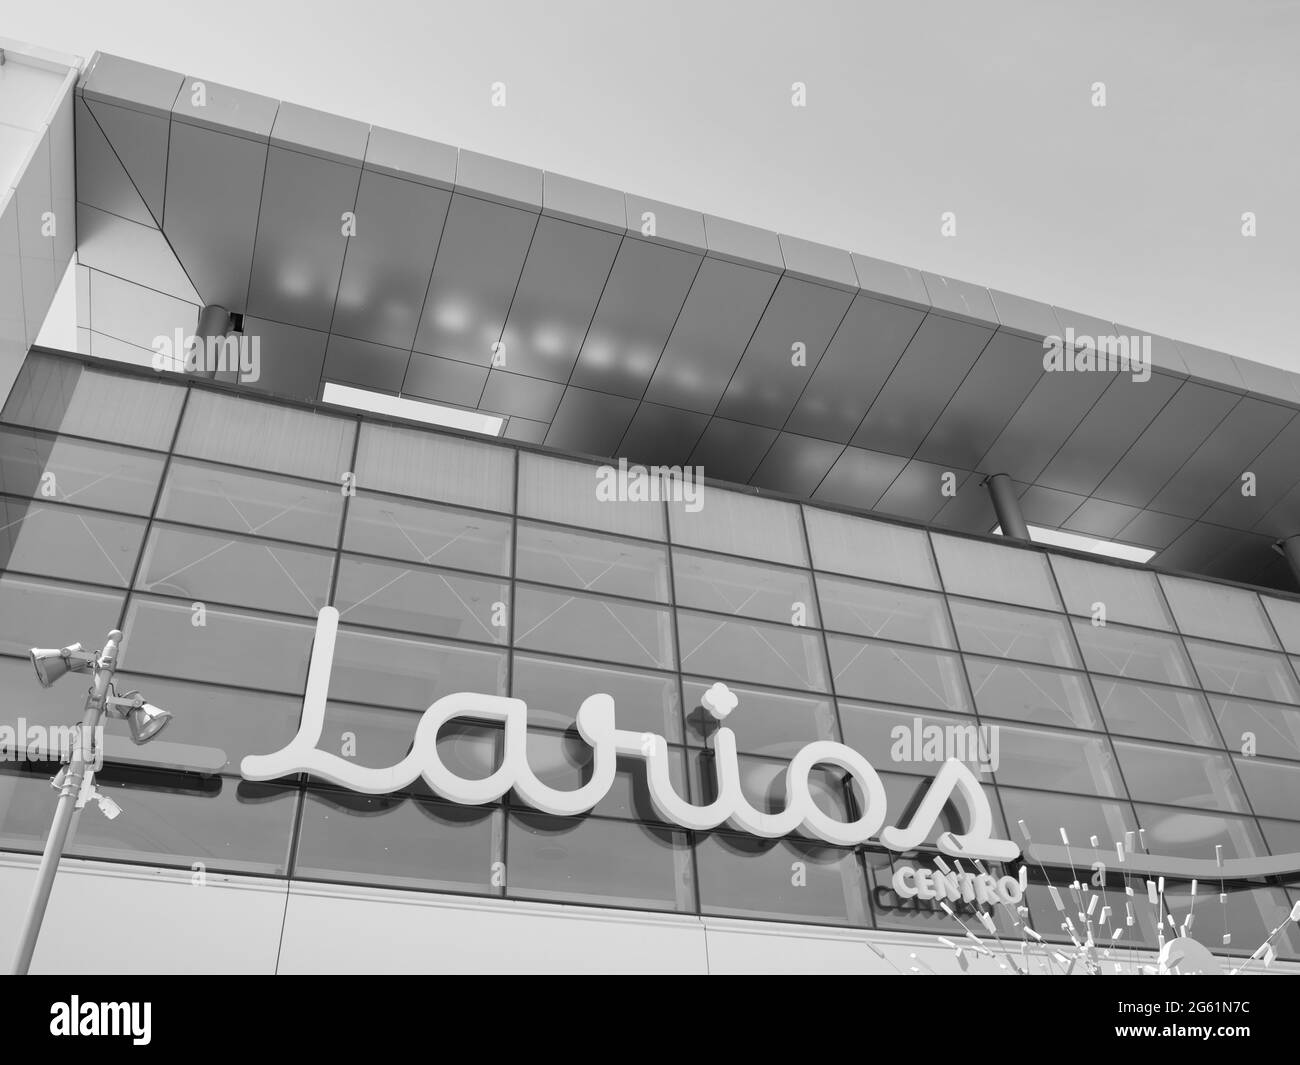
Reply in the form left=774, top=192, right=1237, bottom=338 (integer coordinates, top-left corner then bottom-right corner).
left=157, top=459, right=345, bottom=547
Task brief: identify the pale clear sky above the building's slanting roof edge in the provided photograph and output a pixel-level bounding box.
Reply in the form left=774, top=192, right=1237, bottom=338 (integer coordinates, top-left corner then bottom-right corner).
left=12, top=0, right=1300, bottom=371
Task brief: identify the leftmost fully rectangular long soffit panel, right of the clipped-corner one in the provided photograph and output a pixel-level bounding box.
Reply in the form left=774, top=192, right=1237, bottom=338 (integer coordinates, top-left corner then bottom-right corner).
left=248, top=146, right=361, bottom=330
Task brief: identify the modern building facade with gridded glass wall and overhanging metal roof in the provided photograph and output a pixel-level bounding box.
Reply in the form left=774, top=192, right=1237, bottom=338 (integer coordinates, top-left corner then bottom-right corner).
left=0, top=41, right=1300, bottom=973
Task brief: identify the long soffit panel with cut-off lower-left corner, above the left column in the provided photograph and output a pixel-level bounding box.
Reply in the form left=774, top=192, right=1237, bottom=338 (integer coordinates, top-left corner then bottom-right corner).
left=163, top=122, right=269, bottom=313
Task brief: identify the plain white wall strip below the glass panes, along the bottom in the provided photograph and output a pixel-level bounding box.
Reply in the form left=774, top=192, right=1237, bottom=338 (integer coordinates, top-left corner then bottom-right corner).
left=0, top=853, right=1300, bottom=975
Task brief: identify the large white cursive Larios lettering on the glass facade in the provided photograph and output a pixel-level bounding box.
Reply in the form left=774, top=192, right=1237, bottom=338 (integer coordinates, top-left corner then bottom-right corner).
left=241, top=607, right=1021, bottom=861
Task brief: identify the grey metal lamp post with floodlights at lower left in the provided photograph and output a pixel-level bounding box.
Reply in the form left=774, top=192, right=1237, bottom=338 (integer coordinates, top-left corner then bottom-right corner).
left=13, top=628, right=172, bottom=975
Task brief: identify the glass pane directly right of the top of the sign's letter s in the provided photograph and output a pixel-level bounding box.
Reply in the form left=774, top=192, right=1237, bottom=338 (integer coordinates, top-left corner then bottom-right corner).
left=996, top=724, right=1125, bottom=797
